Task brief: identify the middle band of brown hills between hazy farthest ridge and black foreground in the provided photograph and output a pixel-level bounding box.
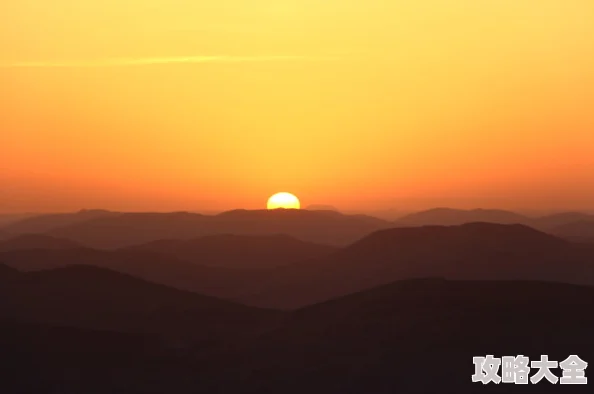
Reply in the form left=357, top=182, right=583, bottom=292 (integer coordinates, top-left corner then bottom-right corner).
left=0, top=223, right=594, bottom=309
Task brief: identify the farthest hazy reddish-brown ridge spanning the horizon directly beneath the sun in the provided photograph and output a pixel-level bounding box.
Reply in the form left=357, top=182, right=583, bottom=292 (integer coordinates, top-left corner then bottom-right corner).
left=0, top=208, right=594, bottom=249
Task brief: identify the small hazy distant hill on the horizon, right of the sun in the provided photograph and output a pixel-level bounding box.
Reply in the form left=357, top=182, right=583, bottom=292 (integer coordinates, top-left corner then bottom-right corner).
left=395, top=208, right=530, bottom=227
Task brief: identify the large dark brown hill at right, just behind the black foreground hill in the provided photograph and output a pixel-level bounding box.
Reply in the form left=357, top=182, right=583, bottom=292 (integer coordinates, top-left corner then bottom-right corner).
left=241, top=223, right=594, bottom=308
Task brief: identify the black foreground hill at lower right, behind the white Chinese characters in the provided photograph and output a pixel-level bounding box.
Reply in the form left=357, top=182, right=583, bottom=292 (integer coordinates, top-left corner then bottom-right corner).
left=219, top=278, right=594, bottom=394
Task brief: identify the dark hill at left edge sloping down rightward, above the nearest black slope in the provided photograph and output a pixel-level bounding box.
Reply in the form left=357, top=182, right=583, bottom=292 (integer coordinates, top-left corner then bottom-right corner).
left=0, top=266, right=278, bottom=341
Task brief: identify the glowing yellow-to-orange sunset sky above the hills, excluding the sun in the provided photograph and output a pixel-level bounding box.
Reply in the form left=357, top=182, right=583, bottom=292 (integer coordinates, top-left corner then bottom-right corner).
left=0, top=0, right=594, bottom=212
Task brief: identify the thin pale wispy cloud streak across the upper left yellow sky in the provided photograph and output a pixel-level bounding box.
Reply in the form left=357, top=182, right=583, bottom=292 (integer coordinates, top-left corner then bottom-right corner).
left=0, top=55, right=337, bottom=68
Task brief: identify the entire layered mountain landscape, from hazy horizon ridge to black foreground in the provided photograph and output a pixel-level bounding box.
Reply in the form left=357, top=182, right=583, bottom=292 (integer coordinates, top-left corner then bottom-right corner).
left=0, top=210, right=594, bottom=394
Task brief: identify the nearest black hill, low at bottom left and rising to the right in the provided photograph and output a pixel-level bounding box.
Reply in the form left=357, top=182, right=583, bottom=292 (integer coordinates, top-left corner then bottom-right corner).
left=0, top=274, right=594, bottom=394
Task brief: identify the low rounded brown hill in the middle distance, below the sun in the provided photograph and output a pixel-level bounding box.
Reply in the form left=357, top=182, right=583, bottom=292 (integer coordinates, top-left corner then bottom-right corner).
left=127, top=234, right=336, bottom=269
